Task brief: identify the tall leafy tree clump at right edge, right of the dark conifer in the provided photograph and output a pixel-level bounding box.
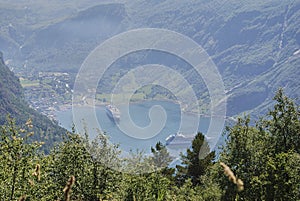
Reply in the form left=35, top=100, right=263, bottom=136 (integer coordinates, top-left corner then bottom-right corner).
left=215, top=89, right=300, bottom=200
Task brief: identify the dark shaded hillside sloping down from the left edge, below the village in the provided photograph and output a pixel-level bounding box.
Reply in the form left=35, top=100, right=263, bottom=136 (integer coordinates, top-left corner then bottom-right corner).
left=0, top=52, right=66, bottom=151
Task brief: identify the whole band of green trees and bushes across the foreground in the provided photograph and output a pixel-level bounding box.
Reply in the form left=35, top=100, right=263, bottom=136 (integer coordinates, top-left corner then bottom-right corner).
left=0, top=90, right=300, bottom=201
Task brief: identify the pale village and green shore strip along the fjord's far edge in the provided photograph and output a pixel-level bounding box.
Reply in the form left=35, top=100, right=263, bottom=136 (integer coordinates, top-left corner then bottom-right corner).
left=18, top=72, right=234, bottom=121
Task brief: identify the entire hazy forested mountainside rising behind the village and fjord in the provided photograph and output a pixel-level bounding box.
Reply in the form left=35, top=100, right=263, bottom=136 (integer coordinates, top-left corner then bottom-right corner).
left=0, top=0, right=300, bottom=116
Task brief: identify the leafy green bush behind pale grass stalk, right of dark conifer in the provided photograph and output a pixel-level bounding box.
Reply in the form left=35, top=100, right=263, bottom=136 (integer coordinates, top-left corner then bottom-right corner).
left=215, top=117, right=268, bottom=200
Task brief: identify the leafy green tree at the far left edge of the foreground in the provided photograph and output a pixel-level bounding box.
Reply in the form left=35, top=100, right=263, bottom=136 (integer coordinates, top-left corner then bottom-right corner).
left=0, top=118, right=41, bottom=200
